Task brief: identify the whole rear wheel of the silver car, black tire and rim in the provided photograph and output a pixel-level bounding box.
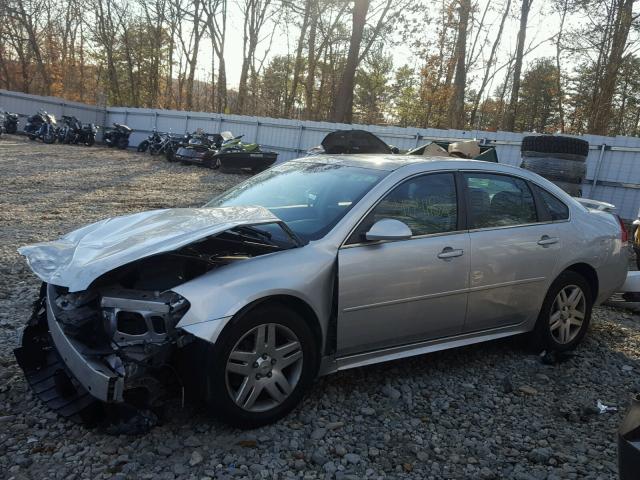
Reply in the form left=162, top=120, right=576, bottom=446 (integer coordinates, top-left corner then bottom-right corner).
left=533, top=270, right=593, bottom=351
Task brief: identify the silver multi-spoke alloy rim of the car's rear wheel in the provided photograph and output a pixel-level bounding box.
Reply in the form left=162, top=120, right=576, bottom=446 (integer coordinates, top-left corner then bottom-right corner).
left=549, top=285, right=587, bottom=344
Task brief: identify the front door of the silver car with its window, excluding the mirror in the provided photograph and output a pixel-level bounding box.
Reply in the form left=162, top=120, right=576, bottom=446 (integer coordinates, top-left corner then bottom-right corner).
left=337, top=172, right=470, bottom=355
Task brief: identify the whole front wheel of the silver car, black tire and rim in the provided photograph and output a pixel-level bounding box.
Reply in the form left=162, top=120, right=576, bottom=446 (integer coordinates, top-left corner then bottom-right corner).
left=205, top=304, right=318, bottom=428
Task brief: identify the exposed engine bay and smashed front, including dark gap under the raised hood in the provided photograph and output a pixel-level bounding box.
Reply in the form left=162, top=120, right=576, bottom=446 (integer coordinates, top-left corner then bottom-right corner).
left=15, top=226, right=295, bottom=433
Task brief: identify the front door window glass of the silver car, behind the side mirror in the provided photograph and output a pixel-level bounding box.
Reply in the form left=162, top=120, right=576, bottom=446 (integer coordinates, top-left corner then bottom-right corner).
left=349, top=173, right=458, bottom=243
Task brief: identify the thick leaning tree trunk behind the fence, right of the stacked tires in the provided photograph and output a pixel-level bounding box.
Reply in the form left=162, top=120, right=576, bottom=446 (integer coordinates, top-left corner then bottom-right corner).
left=588, top=0, right=635, bottom=135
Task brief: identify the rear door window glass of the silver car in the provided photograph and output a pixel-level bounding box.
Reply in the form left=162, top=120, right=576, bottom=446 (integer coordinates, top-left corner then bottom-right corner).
left=464, top=173, right=537, bottom=229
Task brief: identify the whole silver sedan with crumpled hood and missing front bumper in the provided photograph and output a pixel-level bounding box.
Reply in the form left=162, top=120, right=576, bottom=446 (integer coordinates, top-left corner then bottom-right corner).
left=16, top=155, right=627, bottom=427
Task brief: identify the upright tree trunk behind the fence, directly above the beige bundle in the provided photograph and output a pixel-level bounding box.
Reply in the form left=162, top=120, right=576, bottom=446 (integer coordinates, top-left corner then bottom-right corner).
left=448, top=0, right=471, bottom=129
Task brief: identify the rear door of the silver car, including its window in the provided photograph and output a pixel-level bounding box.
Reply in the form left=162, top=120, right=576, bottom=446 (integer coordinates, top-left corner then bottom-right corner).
left=462, top=172, right=560, bottom=332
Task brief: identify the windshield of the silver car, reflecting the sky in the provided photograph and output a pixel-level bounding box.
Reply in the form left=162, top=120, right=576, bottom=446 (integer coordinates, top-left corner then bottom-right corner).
left=205, top=162, right=388, bottom=243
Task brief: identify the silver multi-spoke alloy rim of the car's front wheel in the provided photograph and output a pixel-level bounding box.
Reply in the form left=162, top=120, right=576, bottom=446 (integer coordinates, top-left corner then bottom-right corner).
left=225, top=323, right=303, bottom=412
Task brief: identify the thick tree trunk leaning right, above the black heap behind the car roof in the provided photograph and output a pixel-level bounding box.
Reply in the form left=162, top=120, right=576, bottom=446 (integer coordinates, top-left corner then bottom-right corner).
left=333, top=0, right=369, bottom=123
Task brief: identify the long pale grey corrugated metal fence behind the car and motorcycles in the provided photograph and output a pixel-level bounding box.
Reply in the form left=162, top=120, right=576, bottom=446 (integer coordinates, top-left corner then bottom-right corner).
left=0, top=90, right=640, bottom=219
